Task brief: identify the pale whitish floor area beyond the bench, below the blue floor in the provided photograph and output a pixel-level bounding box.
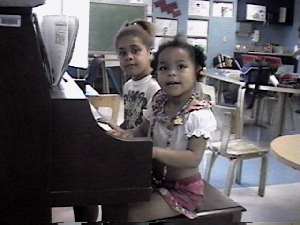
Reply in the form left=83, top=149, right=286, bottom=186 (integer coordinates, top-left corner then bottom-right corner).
left=230, top=183, right=300, bottom=223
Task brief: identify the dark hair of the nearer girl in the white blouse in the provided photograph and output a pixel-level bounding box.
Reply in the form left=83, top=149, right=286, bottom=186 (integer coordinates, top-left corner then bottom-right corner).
left=151, top=34, right=206, bottom=76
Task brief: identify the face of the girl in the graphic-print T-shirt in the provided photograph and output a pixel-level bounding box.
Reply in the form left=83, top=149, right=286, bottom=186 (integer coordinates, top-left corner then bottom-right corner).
left=117, top=35, right=151, bottom=80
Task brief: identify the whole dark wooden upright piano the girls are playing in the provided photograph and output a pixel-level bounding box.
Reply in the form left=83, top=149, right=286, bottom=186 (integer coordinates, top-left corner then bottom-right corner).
left=0, top=5, right=152, bottom=224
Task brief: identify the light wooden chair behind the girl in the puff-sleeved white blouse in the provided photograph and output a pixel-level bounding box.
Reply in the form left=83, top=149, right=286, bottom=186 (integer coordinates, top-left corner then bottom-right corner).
left=204, top=100, right=268, bottom=197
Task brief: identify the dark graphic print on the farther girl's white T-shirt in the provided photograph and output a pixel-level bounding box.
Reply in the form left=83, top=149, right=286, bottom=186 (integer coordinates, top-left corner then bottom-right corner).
left=124, top=90, right=147, bottom=129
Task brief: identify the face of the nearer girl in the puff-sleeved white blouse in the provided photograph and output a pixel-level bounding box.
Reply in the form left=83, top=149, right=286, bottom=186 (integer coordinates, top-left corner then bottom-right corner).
left=157, top=47, right=197, bottom=99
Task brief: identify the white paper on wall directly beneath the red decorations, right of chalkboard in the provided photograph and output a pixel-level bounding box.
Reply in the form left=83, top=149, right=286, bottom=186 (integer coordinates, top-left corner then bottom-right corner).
left=154, top=18, right=177, bottom=36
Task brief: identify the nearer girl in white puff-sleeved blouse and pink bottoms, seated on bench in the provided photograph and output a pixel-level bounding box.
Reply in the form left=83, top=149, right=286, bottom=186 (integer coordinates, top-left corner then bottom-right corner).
left=112, top=34, right=216, bottom=222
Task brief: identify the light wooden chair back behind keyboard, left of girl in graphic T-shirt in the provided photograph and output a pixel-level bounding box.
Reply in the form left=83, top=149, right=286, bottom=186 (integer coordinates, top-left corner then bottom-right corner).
left=88, top=94, right=122, bottom=124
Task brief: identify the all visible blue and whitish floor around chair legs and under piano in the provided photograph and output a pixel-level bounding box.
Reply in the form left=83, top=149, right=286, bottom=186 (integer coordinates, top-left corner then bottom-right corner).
left=52, top=95, right=300, bottom=225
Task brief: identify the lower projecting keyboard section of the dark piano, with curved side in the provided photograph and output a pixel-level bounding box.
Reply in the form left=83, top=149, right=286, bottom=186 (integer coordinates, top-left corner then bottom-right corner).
left=48, top=76, right=152, bottom=221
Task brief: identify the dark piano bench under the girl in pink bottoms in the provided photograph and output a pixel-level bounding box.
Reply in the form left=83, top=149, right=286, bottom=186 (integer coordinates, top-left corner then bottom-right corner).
left=150, top=182, right=246, bottom=225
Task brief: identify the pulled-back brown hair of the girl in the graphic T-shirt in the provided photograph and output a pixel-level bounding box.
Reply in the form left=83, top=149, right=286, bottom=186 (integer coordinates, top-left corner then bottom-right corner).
left=114, top=19, right=155, bottom=49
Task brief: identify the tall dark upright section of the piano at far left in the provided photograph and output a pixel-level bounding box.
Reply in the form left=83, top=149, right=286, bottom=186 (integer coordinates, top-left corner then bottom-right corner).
left=0, top=7, right=51, bottom=224
